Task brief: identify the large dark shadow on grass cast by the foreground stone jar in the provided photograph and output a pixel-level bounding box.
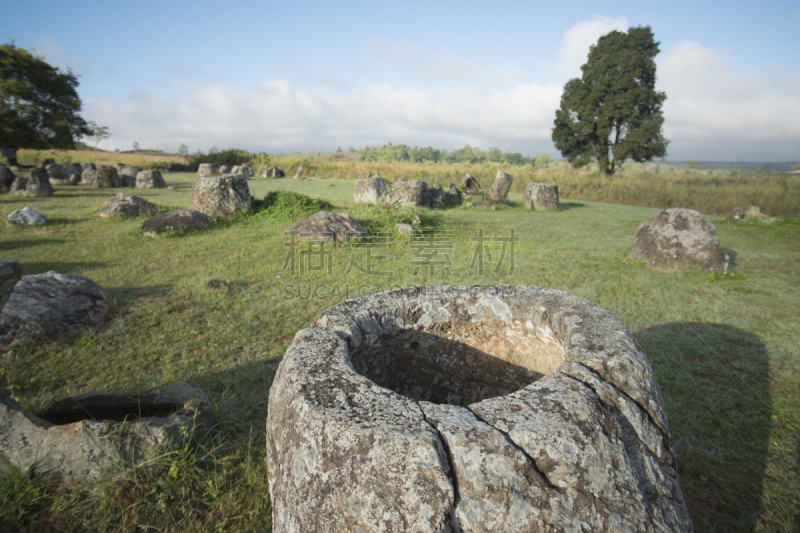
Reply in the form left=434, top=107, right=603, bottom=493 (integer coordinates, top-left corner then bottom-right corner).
left=634, top=323, right=772, bottom=531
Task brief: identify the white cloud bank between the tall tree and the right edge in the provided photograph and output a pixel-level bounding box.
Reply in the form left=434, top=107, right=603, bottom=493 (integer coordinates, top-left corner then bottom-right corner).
left=657, top=41, right=800, bottom=161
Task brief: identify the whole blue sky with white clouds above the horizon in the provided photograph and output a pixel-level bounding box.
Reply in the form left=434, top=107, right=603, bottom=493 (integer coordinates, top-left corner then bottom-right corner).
left=6, top=0, right=800, bottom=162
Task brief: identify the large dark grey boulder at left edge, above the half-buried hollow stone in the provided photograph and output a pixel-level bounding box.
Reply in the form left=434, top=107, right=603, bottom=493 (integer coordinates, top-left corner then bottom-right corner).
left=0, top=270, right=111, bottom=344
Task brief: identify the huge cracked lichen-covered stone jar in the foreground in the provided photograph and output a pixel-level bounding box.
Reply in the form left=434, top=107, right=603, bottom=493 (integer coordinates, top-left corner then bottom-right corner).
left=267, top=286, right=692, bottom=532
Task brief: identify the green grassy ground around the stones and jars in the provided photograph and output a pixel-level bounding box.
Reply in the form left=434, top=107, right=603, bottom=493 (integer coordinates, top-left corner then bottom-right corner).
left=0, top=169, right=800, bottom=531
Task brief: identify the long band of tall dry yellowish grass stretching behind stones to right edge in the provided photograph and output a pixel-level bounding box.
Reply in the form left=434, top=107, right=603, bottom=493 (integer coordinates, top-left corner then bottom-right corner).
left=270, top=157, right=800, bottom=217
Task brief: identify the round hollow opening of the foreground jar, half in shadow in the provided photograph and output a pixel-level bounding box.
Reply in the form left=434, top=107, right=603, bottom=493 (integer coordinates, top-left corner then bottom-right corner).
left=350, top=310, right=565, bottom=406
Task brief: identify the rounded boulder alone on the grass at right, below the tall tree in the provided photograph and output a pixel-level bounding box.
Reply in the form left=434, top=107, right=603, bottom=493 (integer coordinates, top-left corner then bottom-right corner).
left=628, top=208, right=729, bottom=274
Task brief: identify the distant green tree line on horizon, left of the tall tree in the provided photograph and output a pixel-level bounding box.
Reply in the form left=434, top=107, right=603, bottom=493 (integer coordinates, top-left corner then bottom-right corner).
left=361, top=143, right=550, bottom=167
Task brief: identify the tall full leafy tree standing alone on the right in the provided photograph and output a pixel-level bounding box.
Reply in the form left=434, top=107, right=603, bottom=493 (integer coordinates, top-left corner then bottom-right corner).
left=553, top=26, right=669, bottom=177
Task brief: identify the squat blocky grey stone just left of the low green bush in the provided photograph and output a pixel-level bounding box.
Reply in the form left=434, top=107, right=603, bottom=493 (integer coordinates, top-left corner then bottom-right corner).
left=192, top=174, right=253, bottom=216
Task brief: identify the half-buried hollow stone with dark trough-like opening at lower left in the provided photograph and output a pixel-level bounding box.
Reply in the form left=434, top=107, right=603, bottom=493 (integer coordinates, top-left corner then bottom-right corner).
left=0, top=383, right=213, bottom=479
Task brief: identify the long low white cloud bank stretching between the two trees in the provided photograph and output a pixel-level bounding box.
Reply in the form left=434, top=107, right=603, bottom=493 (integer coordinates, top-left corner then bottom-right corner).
left=86, top=80, right=561, bottom=153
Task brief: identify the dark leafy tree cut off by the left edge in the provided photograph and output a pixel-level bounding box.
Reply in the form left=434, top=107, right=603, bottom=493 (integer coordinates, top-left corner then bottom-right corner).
left=0, top=43, right=92, bottom=158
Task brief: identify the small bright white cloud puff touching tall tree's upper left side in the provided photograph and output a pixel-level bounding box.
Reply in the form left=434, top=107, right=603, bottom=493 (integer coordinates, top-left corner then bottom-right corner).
left=556, top=15, right=628, bottom=80
